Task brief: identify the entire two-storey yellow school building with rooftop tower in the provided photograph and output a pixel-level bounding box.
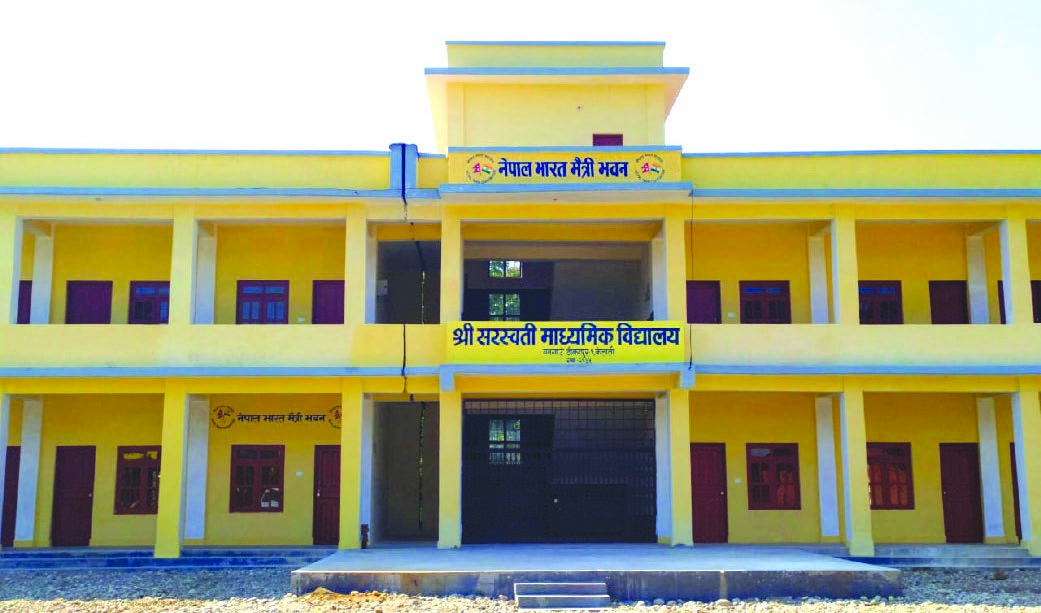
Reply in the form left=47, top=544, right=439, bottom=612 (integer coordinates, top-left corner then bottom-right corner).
left=0, top=43, right=1041, bottom=557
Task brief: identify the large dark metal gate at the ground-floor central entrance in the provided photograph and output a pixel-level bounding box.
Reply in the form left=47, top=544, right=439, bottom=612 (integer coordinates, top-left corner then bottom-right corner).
left=462, top=400, right=656, bottom=543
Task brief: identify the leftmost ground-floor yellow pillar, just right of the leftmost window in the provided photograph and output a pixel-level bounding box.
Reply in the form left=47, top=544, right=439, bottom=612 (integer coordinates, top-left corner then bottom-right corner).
left=155, top=380, right=188, bottom=558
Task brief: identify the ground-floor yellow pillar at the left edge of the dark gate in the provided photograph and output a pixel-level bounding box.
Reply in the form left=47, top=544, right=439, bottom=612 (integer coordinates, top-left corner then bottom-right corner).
left=437, top=389, right=462, bottom=550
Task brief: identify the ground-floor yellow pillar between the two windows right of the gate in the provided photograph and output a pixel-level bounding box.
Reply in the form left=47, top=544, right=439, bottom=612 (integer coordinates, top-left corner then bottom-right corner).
left=840, top=386, right=874, bottom=556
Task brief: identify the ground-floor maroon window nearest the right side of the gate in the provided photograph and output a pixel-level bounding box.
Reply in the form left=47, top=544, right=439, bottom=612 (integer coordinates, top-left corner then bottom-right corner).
left=745, top=442, right=802, bottom=511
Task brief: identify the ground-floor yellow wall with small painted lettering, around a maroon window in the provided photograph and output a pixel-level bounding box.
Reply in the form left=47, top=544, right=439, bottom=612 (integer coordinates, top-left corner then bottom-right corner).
left=205, top=394, right=340, bottom=545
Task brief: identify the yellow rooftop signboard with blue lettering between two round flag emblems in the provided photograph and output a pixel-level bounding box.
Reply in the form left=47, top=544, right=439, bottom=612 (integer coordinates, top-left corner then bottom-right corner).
left=449, top=150, right=681, bottom=185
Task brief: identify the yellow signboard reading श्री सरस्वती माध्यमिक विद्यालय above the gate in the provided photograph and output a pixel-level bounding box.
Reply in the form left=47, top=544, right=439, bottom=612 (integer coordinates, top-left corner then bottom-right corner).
left=446, top=322, right=684, bottom=364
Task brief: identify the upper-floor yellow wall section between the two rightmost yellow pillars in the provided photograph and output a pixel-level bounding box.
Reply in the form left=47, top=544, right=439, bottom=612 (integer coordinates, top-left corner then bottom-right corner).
left=857, top=223, right=968, bottom=324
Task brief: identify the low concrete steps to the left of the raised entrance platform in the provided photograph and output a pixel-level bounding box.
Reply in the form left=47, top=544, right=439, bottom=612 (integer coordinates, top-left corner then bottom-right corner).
left=0, top=547, right=335, bottom=571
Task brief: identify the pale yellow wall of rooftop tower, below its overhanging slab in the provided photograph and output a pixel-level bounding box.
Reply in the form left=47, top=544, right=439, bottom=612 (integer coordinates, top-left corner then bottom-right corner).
left=460, top=84, right=664, bottom=147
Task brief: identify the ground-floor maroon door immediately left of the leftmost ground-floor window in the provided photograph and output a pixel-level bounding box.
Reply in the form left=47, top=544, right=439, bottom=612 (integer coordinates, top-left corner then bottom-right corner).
left=51, top=445, right=95, bottom=547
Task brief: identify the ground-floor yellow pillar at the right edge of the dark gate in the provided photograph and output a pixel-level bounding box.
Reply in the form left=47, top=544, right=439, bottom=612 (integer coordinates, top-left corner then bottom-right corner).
left=668, top=389, right=694, bottom=545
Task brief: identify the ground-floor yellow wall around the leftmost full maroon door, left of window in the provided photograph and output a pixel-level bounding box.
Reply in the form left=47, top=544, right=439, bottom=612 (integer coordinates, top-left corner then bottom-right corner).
left=34, top=394, right=162, bottom=546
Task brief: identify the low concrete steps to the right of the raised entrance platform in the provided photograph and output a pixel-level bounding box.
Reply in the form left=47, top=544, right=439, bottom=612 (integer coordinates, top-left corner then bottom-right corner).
left=843, top=544, right=1041, bottom=570
